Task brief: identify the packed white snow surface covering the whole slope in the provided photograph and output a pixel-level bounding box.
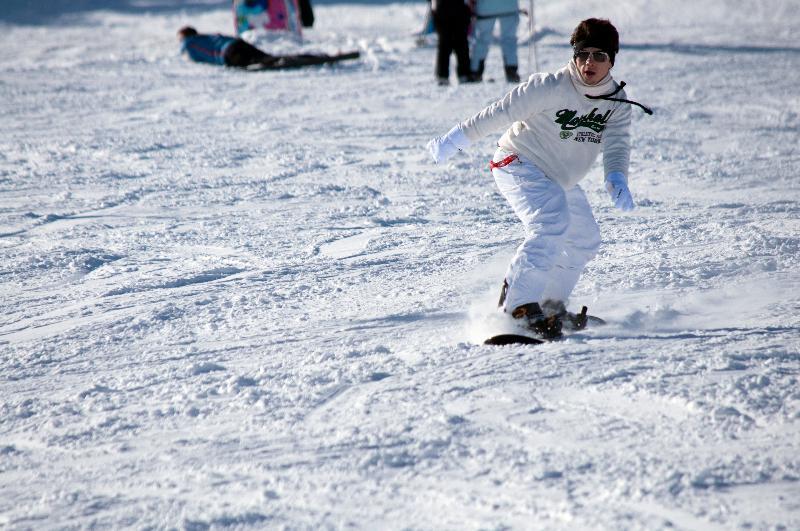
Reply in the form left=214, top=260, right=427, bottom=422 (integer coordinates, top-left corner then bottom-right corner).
left=0, top=0, right=800, bottom=529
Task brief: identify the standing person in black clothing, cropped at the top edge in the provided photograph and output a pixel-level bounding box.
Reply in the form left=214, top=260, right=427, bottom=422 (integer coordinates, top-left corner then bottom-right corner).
left=431, top=0, right=472, bottom=85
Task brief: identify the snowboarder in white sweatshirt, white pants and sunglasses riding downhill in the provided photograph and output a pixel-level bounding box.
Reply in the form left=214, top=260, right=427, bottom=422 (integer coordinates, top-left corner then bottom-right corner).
left=427, top=18, right=652, bottom=338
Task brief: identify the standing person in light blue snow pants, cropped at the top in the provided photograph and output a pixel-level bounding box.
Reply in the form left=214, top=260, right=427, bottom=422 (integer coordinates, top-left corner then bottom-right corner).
left=470, top=0, right=520, bottom=83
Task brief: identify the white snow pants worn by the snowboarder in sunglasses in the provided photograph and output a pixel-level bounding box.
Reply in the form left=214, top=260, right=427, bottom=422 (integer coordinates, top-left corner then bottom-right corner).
left=492, top=149, right=600, bottom=313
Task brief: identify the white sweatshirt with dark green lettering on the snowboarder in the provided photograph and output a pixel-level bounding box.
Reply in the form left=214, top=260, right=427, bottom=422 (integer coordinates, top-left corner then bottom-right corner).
left=461, top=61, right=631, bottom=190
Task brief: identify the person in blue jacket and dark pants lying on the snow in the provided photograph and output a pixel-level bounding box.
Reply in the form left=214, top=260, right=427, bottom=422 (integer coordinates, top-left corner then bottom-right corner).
left=178, top=26, right=359, bottom=70
